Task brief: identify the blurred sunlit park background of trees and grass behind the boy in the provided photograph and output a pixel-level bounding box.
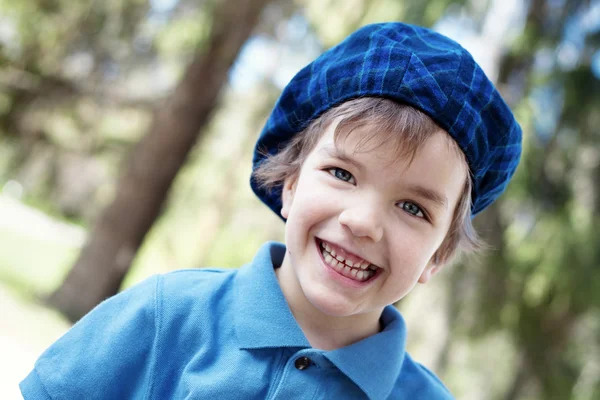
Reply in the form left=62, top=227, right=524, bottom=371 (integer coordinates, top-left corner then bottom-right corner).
left=0, top=0, right=600, bottom=400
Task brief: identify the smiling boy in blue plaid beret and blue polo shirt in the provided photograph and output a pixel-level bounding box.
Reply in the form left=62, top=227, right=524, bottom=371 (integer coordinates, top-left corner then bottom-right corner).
left=21, top=23, right=521, bottom=400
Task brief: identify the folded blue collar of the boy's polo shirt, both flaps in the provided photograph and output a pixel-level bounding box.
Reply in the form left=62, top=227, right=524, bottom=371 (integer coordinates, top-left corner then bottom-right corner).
left=234, top=242, right=406, bottom=399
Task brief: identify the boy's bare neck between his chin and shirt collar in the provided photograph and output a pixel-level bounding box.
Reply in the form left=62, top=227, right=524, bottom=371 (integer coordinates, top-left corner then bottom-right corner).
left=275, top=262, right=381, bottom=350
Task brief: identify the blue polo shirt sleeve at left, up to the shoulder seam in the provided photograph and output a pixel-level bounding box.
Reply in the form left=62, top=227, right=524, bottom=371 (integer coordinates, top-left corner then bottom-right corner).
left=20, top=276, right=161, bottom=400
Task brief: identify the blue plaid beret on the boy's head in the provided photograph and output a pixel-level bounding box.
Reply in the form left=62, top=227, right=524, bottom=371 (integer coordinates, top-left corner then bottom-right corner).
left=250, top=23, right=522, bottom=215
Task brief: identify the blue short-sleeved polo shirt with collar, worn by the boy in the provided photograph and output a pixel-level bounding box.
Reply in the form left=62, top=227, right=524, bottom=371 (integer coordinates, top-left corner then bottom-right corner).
left=20, top=243, right=452, bottom=400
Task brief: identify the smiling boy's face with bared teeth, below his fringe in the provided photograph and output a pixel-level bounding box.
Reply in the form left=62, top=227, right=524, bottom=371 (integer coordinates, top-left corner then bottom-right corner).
left=278, top=123, right=467, bottom=318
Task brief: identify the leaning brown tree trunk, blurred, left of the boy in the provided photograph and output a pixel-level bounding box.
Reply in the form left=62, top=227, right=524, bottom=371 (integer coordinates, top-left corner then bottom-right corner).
left=48, top=0, right=271, bottom=322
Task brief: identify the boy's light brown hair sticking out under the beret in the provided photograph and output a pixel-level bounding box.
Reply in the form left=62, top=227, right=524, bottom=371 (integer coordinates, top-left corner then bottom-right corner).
left=252, top=97, right=481, bottom=264
